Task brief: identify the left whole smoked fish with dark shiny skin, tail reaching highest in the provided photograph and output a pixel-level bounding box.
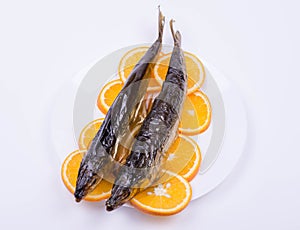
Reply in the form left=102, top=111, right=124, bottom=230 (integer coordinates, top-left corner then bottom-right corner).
left=74, top=10, right=165, bottom=202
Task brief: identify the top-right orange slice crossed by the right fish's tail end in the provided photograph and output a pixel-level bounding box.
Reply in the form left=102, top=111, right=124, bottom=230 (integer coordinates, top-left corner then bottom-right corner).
left=154, top=52, right=205, bottom=94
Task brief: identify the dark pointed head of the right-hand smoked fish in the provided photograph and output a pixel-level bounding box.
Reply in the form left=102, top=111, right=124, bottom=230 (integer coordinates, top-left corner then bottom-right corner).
left=105, top=185, right=131, bottom=212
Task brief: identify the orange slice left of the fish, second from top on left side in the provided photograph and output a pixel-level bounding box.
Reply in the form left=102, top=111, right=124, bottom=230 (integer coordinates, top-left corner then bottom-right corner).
left=97, top=79, right=124, bottom=114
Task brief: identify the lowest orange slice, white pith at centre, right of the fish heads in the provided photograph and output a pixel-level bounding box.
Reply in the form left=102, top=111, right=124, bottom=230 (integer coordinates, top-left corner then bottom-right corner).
left=130, top=171, right=192, bottom=216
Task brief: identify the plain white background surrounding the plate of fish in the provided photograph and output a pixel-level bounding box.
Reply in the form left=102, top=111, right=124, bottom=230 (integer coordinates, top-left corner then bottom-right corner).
left=0, top=0, right=300, bottom=230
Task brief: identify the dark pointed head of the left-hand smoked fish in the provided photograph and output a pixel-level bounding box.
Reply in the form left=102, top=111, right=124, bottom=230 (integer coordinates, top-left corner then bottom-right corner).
left=74, top=164, right=103, bottom=202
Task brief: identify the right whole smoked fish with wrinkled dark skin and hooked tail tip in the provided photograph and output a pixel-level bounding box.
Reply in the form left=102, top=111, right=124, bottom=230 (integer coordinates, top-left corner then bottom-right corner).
left=106, top=20, right=187, bottom=211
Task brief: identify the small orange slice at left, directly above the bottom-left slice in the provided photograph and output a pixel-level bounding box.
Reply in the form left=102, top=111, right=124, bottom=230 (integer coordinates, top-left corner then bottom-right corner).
left=78, top=118, right=104, bottom=150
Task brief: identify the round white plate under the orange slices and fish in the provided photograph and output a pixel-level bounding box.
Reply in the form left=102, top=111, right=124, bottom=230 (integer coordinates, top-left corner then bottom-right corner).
left=50, top=44, right=247, bottom=199
